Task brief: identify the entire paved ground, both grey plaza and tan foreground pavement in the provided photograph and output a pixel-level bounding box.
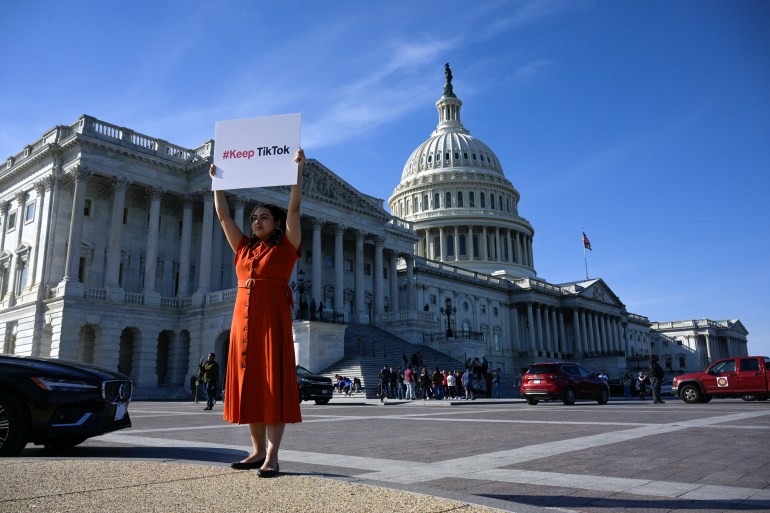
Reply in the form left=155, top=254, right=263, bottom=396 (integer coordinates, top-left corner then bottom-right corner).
left=0, top=398, right=770, bottom=513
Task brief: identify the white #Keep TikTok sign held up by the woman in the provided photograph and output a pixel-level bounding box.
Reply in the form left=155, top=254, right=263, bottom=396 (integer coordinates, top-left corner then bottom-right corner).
left=211, top=113, right=302, bottom=191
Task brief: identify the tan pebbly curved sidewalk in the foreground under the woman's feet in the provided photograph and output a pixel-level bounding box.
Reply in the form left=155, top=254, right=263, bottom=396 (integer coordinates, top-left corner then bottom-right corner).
left=6, top=458, right=508, bottom=513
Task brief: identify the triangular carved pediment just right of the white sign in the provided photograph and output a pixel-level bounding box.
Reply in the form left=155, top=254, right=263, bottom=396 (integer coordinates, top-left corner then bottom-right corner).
left=302, top=159, right=390, bottom=223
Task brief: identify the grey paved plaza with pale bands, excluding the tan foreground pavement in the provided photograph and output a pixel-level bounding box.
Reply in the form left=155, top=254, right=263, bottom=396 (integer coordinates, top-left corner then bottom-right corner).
left=6, top=398, right=770, bottom=512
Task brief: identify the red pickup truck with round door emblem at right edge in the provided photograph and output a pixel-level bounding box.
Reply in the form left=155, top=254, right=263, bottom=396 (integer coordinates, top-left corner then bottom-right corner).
left=671, top=356, right=770, bottom=404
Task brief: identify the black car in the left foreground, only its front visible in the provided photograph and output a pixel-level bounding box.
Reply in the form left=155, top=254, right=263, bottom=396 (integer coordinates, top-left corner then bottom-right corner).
left=0, top=355, right=133, bottom=456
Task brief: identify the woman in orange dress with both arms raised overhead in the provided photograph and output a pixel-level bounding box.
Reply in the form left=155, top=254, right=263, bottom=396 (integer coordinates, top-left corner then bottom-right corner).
left=210, top=149, right=305, bottom=477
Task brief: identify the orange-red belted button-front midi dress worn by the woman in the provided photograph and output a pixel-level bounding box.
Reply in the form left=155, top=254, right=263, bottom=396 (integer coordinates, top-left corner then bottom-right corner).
left=224, top=237, right=302, bottom=424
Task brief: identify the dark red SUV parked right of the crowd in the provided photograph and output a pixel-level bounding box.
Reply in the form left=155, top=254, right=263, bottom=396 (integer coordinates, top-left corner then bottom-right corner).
left=519, top=362, right=610, bottom=405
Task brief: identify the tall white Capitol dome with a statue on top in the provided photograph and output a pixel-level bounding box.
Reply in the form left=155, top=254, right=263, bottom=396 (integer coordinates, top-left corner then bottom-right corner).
left=388, top=64, right=536, bottom=277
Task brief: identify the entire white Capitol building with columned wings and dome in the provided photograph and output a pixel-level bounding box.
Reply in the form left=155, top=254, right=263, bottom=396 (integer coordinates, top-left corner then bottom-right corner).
left=0, top=66, right=748, bottom=398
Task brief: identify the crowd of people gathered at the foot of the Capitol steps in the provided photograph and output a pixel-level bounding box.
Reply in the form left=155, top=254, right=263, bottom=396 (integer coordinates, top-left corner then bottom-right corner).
left=377, top=352, right=500, bottom=401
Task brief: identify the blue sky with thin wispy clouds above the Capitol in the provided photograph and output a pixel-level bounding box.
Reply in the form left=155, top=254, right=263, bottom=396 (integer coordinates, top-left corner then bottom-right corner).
left=0, top=0, right=770, bottom=355
